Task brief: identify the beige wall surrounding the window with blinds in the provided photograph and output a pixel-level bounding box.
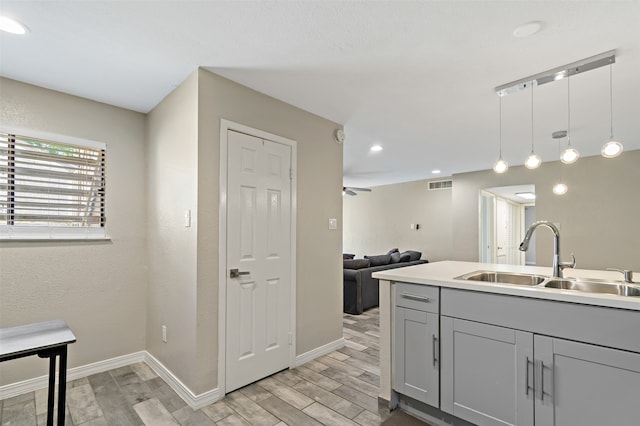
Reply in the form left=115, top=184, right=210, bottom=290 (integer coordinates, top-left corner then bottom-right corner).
left=0, top=78, right=147, bottom=385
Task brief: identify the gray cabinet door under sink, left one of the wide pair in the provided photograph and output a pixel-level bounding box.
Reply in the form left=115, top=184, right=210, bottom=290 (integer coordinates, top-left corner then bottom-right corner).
left=440, top=316, right=534, bottom=426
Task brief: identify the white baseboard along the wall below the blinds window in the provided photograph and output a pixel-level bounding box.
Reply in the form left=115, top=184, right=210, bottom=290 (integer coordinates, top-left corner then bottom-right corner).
left=0, top=351, right=146, bottom=399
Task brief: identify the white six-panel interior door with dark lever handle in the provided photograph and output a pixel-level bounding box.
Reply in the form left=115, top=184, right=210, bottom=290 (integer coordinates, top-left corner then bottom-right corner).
left=225, top=130, right=292, bottom=392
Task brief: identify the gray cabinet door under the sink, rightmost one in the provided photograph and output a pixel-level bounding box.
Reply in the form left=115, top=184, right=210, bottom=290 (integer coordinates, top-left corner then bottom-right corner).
left=534, top=336, right=640, bottom=426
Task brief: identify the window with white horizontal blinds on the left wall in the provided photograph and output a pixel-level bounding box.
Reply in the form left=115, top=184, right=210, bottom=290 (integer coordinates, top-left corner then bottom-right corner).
left=0, top=132, right=106, bottom=238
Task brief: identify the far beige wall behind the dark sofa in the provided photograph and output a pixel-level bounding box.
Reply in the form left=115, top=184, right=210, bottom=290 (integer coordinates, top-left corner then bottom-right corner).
left=343, top=180, right=453, bottom=261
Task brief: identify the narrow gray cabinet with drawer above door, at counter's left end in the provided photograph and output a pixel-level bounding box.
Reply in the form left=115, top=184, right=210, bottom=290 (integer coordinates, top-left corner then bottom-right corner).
left=393, top=283, right=440, bottom=407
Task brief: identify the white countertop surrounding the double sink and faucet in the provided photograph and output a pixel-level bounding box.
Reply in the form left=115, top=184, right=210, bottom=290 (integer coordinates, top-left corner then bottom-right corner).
left=373, top=260, right=640, bottom=311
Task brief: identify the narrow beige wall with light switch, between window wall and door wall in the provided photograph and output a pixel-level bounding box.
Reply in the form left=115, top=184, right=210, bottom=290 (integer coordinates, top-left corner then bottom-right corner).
left=146, top=72, right=200, bottom=391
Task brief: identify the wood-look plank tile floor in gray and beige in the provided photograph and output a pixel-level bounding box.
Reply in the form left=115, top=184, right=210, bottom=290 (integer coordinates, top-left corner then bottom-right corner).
left=0, top=308, right=389, bottom=426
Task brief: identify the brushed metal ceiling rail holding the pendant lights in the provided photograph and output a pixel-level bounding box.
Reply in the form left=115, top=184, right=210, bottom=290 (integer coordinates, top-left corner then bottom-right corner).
left=495, top=50, right=616, bottom=96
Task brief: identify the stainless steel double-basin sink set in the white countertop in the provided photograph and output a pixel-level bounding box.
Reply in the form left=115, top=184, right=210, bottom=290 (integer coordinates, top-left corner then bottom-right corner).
left=455, top=271, right=640, bottom=297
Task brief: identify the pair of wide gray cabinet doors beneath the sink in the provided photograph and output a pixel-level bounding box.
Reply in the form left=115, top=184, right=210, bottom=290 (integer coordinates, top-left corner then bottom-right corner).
left=440, top=316, right=640, bottom=426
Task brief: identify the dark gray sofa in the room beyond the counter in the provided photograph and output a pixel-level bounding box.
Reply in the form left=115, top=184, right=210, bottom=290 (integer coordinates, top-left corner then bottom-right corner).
left=343, top=250, right=428, bottom=315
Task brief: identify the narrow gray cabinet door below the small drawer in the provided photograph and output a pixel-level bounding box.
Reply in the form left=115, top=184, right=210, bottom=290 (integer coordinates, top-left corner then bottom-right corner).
left=393, top=306, right=440, bottom=407
